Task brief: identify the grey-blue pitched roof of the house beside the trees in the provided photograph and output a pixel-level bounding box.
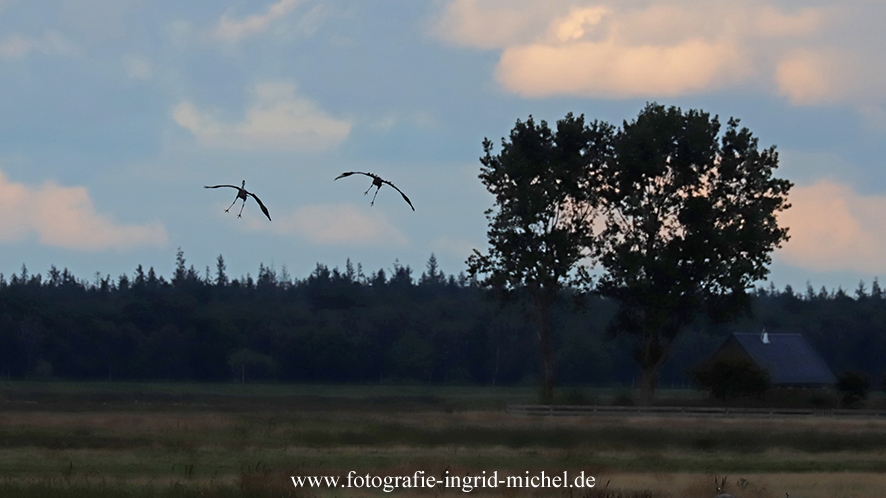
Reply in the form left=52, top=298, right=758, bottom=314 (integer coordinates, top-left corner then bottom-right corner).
left=732, top=333, right=837, bottom=385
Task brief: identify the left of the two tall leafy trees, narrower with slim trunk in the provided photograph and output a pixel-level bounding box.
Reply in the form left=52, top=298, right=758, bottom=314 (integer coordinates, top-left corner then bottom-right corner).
left=467, top=114, right=613, bottom=403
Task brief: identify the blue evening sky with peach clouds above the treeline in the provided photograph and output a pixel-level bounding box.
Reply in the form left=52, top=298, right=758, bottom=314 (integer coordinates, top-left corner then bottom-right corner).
left=0, top=0, right=886, bottom=291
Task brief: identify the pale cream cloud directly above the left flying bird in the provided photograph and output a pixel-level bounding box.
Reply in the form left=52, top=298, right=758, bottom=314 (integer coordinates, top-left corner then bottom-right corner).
left=172, top=83, right=352, bottom=150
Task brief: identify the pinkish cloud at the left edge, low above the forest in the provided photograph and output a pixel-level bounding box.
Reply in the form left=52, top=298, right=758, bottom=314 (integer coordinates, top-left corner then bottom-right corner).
left=0, top=172, right=167, bottom=251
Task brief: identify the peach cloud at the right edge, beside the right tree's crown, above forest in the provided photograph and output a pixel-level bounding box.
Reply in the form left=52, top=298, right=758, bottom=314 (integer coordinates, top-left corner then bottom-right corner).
left=779, top=180, right=886, bottom=273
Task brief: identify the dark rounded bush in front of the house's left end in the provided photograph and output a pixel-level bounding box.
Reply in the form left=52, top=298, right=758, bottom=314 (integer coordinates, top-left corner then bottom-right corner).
left=689, top=358, right=770, bottom=401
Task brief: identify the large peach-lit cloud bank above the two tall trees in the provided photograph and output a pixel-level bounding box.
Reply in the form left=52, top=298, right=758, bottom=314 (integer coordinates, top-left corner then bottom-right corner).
left=431, top=0, right=886, bottom=109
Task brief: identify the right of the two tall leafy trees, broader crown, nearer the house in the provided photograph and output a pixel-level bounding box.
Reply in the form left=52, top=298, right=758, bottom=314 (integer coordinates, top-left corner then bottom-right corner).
left=598, top=104, right=791, bottom=404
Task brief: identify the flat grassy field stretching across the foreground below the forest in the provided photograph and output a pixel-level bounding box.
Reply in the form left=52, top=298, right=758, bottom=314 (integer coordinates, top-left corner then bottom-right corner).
left=0, top=383, right=886, bottom=498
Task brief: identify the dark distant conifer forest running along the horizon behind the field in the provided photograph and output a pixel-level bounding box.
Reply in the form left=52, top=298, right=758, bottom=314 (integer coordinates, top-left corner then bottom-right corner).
left=0, top=250, right=886, bottom=388
